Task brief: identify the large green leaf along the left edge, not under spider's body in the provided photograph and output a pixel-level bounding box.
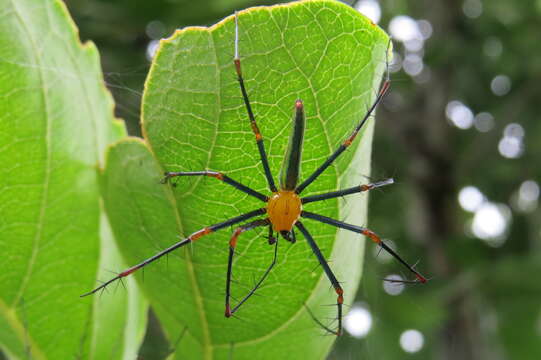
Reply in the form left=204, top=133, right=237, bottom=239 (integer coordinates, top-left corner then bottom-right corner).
left=0, top=0, right=146, bottom=359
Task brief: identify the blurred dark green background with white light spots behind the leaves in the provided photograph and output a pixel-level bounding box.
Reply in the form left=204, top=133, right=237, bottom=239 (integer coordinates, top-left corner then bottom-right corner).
left=66, top=0, right=541, bottom=360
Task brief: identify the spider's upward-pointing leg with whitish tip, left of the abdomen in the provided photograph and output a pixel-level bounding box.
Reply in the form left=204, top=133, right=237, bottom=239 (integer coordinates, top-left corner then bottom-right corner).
left=233, top=12, right=277, bottom=192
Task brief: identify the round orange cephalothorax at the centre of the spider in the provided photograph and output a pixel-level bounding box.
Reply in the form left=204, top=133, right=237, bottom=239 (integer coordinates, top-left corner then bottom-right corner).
left=267, top=190, right=302, bottom=231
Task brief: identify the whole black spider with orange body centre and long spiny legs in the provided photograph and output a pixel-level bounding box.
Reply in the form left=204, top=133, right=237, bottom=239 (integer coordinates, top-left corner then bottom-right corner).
left=81, top=13, right=427, bottom=335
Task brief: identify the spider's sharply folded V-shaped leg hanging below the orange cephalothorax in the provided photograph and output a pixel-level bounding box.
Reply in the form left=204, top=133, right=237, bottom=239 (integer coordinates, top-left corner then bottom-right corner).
left=225, top=219, right=278, bottom=317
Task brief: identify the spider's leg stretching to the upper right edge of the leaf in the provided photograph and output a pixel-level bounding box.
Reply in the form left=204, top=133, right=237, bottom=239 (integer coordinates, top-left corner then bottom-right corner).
left=295, top=40, right=391, bottom=194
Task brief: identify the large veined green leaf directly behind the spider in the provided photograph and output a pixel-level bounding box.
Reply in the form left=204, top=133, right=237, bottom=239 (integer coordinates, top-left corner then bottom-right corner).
left=104, top=1, right=388, bottom=359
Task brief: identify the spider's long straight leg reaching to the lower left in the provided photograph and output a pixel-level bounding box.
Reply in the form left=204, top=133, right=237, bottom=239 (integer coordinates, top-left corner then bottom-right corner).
left=81, top=208, right=267, bottom=297
